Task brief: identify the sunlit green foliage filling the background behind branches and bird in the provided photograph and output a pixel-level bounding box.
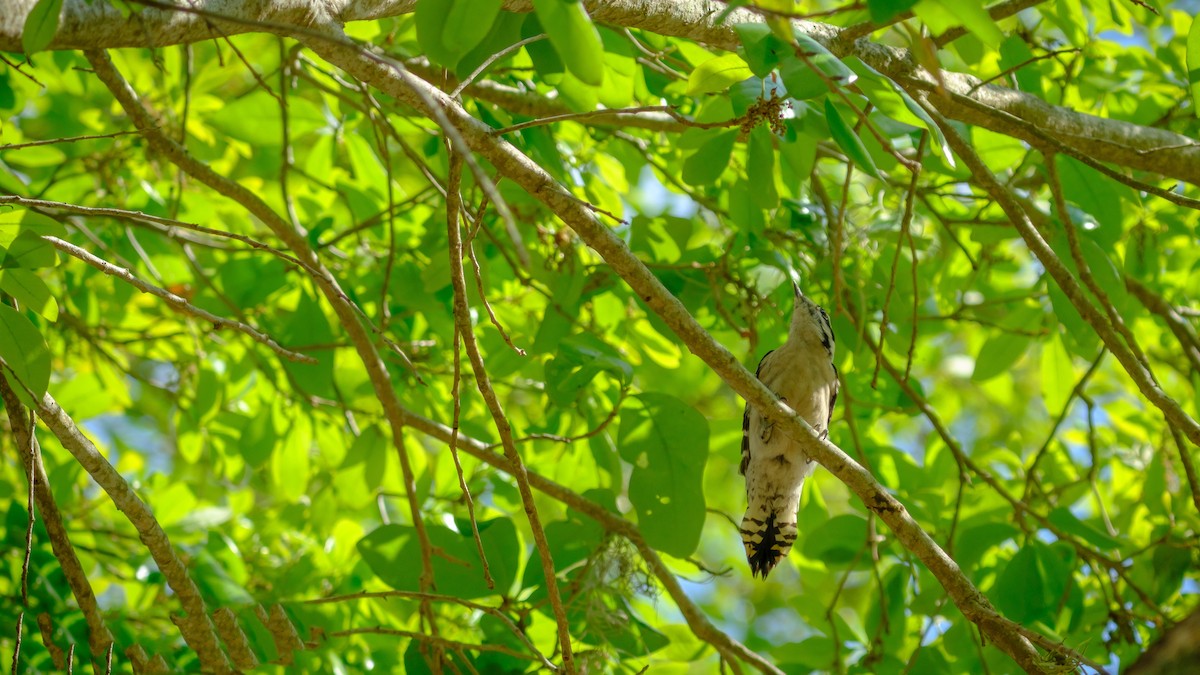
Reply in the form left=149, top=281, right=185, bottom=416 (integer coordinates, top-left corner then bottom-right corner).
left=0, top=0, right=1200, bottom=674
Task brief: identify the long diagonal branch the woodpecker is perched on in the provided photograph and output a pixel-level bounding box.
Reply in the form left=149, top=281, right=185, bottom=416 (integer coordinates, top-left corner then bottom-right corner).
left=306, top=30, right=1042, bottom=671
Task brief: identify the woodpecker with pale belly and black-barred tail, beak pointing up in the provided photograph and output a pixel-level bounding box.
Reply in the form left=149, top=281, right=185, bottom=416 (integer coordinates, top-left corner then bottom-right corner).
left=739, top=281, right=838, bottom=579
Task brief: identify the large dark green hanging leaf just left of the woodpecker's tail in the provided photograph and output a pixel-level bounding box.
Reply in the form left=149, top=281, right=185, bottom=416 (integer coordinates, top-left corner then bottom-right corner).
left=617, top=393, right=708, bottom=557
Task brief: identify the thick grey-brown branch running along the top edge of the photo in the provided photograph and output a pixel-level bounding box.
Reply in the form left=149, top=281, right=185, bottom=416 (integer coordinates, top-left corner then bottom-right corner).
left=0, top=0, right=1200, bottom=185
